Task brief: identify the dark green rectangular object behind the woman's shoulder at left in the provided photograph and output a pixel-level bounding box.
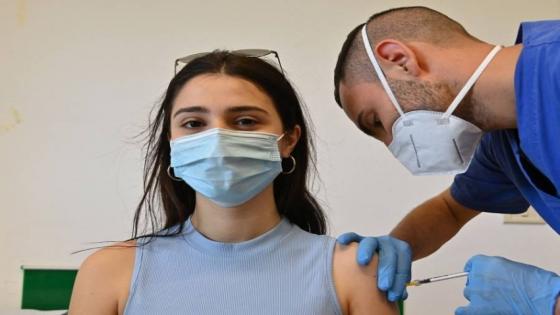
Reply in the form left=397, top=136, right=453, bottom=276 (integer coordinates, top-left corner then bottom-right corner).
left=21, top=266, right=78, bottom=311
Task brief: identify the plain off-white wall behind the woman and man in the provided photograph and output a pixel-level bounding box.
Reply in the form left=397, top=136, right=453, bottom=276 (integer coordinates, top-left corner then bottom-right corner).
left=0, top=0, right=560, bottom=314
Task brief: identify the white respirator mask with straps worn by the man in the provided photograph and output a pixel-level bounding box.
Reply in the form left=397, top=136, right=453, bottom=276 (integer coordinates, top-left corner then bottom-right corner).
left=362, top=24, right=501, bottom=175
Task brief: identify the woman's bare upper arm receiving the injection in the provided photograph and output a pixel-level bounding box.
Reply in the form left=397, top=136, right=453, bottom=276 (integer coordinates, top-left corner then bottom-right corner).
left=333, top=243, right=398, bottom=315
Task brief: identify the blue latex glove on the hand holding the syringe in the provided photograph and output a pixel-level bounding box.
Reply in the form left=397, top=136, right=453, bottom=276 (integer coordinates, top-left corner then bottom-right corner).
left=455, top=255, right=560, bottom=315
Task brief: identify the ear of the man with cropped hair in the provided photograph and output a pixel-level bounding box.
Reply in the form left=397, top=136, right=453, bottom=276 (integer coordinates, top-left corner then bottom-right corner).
left=375, top=39, right=422, bottom=77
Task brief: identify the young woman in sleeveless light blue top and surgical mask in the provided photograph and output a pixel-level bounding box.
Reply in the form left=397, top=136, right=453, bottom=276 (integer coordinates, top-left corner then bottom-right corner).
left=70, top=51, right=397, bottom=315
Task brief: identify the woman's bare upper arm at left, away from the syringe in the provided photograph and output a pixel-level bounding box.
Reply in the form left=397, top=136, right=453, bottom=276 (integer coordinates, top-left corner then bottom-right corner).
left=69, top=242, right=135, bottom=315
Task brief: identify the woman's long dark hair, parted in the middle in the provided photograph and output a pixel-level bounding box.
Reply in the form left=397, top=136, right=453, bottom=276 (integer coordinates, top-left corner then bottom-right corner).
left=132, top=51, right=326, bottom=239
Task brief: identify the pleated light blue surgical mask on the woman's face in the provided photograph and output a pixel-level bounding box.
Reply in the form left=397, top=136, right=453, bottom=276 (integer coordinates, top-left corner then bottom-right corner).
left=171, top=128, right=282, bottom=208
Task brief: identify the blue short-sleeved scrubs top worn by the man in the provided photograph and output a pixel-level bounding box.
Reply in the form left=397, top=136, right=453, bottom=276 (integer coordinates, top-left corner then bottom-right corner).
left=451, top=20, right=560, bottom=234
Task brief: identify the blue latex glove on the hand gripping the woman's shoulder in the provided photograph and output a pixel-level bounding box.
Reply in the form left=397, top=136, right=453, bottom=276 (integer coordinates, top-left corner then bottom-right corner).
left=338, top=233, right=412, bottom=302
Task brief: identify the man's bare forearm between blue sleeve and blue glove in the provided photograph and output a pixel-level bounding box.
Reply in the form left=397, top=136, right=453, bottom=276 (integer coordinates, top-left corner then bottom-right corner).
left=391, top=190, right=478, bottom=260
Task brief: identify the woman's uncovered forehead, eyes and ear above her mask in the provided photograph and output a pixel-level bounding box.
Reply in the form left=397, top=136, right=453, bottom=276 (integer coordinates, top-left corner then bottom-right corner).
left=170, top=74, right=300, bottom=157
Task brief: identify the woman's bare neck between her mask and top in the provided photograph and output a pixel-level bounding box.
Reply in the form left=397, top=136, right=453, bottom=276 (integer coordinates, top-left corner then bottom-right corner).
left=191, top=185, right=281, bottom=243
